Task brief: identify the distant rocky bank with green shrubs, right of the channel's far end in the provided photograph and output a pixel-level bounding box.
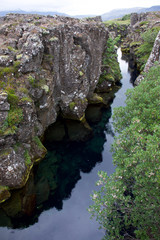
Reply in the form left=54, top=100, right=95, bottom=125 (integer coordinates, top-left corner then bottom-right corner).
left=122, top=12, right=160, bottom=72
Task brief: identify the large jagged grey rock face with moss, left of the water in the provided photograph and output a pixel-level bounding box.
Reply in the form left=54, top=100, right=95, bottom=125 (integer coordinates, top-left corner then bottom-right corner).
left=0, top=14, right=108, bottom=199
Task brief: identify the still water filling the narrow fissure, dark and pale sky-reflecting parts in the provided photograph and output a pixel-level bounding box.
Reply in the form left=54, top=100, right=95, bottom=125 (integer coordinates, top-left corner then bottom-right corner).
left=0, top=49, right=137, bottom=240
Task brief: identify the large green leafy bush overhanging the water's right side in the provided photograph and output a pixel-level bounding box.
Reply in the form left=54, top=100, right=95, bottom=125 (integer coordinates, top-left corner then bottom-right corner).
left=89, top=63, right=160, bottom=240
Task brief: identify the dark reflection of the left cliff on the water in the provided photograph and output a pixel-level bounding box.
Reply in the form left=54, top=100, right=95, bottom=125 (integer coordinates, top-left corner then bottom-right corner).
left=0, top=103, right=114, bottom=228
